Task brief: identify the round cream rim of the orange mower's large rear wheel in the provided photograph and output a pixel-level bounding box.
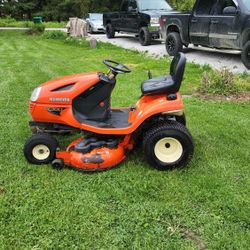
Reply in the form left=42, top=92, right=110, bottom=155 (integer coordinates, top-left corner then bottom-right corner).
left=154, top=137, right=183, bottom=164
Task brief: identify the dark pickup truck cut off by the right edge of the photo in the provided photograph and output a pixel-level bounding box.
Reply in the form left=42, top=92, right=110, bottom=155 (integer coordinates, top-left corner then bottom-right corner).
left=160, top=0, right=250, bottom=69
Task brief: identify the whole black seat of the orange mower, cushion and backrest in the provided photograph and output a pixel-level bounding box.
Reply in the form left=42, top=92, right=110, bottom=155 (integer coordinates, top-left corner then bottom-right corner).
left=141, top=53, right=186, bottom=95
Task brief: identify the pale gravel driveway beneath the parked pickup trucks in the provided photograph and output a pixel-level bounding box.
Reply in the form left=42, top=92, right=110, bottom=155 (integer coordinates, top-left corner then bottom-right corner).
left=90, top=34, right=250, bottom=73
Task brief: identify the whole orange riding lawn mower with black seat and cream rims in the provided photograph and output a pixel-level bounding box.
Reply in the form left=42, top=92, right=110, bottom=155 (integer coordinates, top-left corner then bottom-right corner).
left=24, top=53, right=194, bottom=171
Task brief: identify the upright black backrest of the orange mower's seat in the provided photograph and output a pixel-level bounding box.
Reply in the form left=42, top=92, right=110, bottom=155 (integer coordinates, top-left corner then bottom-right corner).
left=170, top=53, right=187, bottom=92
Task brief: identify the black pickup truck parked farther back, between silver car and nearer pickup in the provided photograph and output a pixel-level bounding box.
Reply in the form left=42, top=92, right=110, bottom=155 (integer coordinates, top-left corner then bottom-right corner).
left=103, top=0, right=172, bottom=46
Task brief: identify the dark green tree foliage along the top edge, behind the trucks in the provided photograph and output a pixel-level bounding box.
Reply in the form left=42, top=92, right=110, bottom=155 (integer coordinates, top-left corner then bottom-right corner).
left=0, top=0, right=194, bottom=22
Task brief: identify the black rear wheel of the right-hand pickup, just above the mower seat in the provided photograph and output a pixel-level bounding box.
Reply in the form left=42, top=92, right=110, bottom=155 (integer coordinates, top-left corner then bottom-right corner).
left=166, top=32, right=183, bottom=56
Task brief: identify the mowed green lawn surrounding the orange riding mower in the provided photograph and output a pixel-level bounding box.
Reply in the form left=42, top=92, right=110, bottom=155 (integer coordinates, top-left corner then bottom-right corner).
left=0, top=32, right=250, bottom=250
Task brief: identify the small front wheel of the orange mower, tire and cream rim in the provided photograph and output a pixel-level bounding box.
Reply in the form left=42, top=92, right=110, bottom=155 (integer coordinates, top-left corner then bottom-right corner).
left=23, top=133, right=58, bottom=165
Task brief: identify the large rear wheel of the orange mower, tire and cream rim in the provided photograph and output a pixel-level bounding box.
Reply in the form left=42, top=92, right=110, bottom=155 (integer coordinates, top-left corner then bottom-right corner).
left=143, top=121, right=194, bottom=170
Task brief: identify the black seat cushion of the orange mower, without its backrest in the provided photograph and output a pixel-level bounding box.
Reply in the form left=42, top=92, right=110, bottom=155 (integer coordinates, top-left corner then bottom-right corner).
left=141, top=75, right=175, bottom=95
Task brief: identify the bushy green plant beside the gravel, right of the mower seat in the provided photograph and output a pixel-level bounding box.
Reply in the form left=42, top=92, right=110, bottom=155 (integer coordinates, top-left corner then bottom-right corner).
left=199, top=68, right=239, bottom=96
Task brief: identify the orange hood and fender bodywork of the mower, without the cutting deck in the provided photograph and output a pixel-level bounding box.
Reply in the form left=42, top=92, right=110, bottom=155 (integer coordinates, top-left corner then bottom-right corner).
left=30, top=72, right=183, bottom=135
